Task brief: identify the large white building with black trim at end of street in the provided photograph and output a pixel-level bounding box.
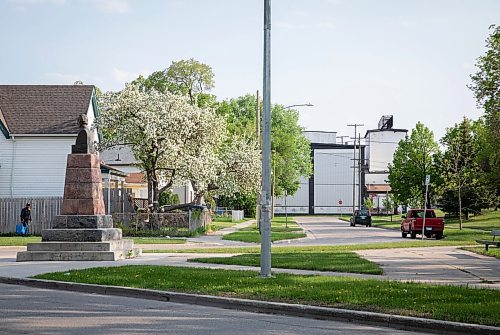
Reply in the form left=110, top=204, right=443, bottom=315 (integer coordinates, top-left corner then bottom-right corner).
left=275, top=131, right=365, bottom=214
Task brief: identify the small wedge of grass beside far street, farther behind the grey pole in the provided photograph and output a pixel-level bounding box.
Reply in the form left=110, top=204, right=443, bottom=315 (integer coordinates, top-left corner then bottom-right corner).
left=223, top=217, right=307, bottom=243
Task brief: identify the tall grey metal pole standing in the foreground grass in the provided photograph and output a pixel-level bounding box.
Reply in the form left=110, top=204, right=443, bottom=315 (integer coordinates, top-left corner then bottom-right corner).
left=260, top=0, right=271, bottom=278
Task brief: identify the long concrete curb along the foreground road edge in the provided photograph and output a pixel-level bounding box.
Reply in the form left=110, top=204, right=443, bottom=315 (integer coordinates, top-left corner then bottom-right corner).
left=0, top=277, right=500, bottom=335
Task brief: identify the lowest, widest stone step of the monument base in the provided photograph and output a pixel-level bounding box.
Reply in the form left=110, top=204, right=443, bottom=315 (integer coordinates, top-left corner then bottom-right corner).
left=17, top=248, right=142, bottom=262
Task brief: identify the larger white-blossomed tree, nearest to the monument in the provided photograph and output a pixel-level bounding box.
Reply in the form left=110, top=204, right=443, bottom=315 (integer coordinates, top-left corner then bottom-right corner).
left=96, top=85, right=214, bottom=211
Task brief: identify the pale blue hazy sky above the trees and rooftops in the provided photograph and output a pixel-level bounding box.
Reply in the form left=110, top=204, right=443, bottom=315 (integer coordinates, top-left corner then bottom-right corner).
left=0, top=0, right=500, bottom=138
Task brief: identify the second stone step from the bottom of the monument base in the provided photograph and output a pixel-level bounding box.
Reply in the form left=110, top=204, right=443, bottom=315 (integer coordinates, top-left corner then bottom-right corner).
left=27, top=240, right=134, bottom=251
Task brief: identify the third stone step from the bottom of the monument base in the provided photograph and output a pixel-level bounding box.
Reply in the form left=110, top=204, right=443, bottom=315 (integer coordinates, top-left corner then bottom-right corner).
left=42, top=228, right=122, bottom=242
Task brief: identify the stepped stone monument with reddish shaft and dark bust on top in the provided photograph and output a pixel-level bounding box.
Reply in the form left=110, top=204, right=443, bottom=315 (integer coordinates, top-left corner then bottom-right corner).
left=17, top=114, right=141, bottom=262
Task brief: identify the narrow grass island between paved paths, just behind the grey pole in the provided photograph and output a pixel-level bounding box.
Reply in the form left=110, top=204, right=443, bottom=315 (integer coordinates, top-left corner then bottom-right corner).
left=189, top=251, right=382, bottom=275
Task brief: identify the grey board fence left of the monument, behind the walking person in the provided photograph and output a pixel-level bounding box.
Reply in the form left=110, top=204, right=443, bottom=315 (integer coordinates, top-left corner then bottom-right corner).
left=0, top=197, right=62, bottom=234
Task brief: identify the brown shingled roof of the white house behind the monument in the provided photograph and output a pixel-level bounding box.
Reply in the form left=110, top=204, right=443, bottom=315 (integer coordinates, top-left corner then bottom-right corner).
left=0, top=85, right=94, bottom=135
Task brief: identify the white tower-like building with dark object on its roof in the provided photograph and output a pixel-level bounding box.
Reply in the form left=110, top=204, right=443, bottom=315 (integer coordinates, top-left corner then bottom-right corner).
left=364, top=115, right=408, bottom=212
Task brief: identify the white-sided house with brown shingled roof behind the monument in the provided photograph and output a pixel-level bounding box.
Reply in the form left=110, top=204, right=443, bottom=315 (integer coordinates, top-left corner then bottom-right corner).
left=0, top=85, right=98, bottom=198
